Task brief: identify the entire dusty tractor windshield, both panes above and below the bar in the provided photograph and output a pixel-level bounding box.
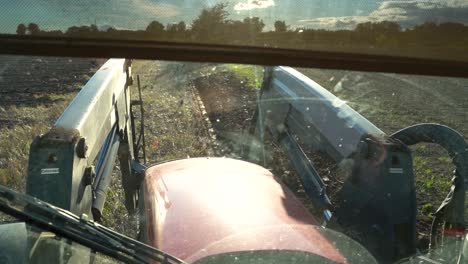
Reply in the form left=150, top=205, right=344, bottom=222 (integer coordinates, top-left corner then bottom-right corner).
left=0, top=0, right=468, bottom=263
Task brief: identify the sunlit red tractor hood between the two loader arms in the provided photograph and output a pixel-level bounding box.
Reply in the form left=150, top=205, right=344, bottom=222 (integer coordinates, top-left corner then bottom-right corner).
left=143, top=158, right=347, bottom=263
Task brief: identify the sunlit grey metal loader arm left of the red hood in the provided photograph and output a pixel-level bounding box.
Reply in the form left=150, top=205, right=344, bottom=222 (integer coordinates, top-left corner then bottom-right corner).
left=26, top=59, right=142, bottom=221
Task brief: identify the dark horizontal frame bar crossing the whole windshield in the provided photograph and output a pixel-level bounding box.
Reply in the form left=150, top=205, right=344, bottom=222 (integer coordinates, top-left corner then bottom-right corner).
left=0, top=34, right=468, bottom=77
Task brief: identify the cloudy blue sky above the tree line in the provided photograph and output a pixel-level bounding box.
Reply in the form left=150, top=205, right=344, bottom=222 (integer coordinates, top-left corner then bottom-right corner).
left=0, top=0, right=468, bottom=33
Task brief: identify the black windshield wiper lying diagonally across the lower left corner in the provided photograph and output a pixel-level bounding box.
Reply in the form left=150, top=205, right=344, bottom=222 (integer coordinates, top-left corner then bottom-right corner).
left=0, top=185, right=184, bottom=264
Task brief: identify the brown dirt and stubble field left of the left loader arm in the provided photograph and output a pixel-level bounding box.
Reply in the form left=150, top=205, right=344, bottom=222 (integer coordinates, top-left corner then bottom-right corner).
left=0, top=55, right=102, bottom=191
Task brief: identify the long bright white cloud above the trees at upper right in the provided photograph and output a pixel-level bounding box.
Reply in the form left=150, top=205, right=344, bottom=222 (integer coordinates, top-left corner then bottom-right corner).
left=297, top=0, right=468, bottom=29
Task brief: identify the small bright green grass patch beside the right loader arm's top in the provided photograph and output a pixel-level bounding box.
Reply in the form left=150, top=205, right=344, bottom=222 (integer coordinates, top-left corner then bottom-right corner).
left=224, top=64, right=263, bottom=89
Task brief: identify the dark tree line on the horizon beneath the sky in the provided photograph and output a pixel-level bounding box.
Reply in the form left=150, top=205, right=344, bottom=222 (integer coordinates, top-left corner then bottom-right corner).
left=16, top=3, right=468, bottom=59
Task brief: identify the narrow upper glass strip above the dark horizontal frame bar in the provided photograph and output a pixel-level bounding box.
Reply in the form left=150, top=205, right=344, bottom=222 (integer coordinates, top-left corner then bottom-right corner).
left=0, top=0, right=468, bottom=62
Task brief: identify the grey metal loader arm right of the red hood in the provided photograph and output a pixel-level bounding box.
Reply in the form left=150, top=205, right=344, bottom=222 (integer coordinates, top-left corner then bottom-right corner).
left=252, top=67, right=416, bottom=262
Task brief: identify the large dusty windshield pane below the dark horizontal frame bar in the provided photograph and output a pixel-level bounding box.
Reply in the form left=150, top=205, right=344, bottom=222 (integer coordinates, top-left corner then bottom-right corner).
left=0, top=55, right=468, bottom=263
